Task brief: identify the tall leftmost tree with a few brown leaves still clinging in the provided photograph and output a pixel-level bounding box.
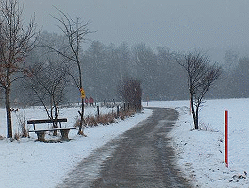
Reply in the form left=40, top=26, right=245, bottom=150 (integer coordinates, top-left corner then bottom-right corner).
left=0, top=0, right=36, bottom=138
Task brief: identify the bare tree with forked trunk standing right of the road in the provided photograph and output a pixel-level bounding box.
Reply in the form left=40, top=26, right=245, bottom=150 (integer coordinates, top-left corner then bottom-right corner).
left=177, top=53, right=222, bottom=129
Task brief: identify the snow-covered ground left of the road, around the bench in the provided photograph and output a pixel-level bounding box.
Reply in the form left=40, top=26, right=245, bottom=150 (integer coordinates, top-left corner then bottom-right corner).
left=0, top=107, right=152, bottom=188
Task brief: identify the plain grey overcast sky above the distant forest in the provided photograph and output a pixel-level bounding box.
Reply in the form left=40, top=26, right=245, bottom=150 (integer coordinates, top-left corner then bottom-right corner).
left=21, top=0, right=249, bottom=50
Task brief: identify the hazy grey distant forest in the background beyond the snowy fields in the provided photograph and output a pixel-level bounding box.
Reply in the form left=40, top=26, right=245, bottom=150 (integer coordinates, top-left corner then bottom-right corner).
left=2, top=32, right=249, bottom=105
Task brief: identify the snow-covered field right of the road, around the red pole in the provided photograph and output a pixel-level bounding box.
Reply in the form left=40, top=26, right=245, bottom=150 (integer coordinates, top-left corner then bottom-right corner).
left=149, top=99, right=249, bottom=188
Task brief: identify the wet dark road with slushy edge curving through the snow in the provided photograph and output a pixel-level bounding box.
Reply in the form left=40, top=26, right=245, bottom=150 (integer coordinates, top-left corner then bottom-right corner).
left=58, top=108, right=191, bottom=188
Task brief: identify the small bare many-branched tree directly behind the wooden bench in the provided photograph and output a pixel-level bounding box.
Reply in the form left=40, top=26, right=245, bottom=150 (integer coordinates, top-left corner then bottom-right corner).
left=25, top=61, right=68, bottom=136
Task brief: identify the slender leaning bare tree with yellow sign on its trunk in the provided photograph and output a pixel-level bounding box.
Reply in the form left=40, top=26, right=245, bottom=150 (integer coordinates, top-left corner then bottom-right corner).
left=49, top=9, right=91, bottom=135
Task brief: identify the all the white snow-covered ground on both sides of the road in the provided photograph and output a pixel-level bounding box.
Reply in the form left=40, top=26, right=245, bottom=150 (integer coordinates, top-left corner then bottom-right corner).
left=0, top=99, right=249, bottom=187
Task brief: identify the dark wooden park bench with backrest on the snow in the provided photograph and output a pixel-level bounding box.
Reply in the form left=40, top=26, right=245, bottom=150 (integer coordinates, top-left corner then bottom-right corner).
left=27, top=118, right=76, bottom=142
